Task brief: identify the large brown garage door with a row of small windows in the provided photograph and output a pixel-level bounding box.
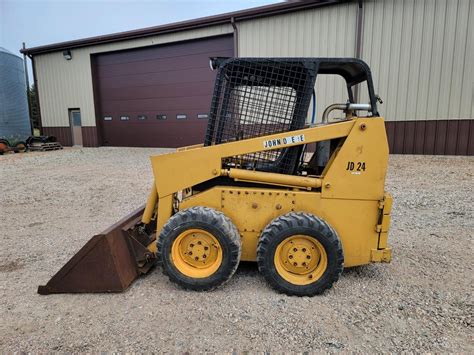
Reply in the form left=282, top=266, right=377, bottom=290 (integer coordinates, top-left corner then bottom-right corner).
left=94, top=36, right=233, bottom=147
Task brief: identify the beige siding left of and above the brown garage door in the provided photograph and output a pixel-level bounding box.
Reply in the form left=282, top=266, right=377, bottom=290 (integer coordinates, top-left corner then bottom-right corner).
left=35, top=24, right=233, bottom=127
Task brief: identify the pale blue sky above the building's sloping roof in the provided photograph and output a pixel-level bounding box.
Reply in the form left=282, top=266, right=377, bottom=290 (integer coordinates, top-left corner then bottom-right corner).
left=0, top=0, right=279, bottom=55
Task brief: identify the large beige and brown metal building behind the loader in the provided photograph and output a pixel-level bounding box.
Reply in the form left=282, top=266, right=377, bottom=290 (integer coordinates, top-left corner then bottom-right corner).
left=20, top=0, right=474, bottom=155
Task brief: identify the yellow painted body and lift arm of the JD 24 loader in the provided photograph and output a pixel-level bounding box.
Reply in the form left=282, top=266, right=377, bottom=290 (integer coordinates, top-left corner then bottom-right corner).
left=145, top=117, right=392, bottom=266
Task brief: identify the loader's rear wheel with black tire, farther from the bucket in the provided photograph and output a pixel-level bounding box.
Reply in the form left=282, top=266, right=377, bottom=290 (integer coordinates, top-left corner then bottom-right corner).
left=257, top=212, right=344, bottom=296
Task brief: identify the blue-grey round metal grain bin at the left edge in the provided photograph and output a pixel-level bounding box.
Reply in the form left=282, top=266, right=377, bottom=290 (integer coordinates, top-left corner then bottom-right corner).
left=0, top=47, right=31, bottom=143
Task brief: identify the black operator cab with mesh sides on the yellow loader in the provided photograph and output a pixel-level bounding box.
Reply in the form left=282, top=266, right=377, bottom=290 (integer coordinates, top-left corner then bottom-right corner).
left=204, top=57, right=379, bottom=175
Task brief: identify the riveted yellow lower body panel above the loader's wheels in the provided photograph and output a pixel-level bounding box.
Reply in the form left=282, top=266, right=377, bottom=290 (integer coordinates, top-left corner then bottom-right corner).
left=179, top=186, right=379, bottom=266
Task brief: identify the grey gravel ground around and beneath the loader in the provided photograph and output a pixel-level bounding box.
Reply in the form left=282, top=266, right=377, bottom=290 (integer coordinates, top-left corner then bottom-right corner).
left=0, top=148, right=474, bottom=353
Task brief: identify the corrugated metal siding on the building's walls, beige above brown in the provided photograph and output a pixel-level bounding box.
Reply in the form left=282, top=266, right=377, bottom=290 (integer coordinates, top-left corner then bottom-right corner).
left=32, top=0, right=474, bottom=154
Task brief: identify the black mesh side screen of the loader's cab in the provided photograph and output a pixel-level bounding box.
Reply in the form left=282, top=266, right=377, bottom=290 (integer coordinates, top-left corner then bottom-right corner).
left=205, top=58, right=315, bottom=174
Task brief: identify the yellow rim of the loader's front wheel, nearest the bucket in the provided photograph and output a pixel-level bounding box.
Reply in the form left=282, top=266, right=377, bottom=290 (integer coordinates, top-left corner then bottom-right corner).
left=171, top=229, right=222, bottom=279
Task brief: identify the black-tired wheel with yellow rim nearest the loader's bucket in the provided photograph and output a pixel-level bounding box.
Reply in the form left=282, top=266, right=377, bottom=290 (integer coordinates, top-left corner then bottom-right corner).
left=157, top=207, right=242, bottom=291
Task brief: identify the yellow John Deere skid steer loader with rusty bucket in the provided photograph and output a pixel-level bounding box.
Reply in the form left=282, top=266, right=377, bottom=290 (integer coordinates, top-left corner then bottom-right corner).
left=38, top=58, right=392, bottom=296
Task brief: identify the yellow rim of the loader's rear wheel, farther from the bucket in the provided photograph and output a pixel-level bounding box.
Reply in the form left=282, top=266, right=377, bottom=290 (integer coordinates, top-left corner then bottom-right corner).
left=274, top=235, right=328, bottom=285
